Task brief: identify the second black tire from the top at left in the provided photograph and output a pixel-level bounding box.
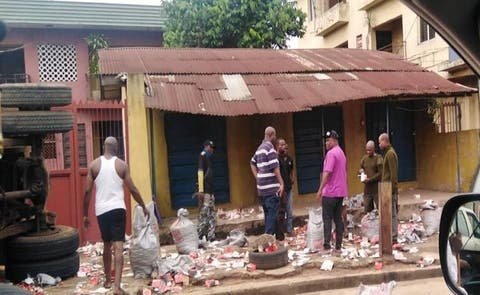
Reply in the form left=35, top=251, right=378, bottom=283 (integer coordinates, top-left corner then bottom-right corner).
left=1, top=111, right=73, bottom=137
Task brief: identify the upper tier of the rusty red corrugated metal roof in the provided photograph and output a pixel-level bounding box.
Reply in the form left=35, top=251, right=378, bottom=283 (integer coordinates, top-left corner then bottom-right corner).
left=99, top=47, right=423, bottom=75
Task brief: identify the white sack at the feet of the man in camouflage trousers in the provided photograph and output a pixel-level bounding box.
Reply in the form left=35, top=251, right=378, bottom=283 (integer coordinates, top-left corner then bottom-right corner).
left=170, top=208, right=199, bottom=254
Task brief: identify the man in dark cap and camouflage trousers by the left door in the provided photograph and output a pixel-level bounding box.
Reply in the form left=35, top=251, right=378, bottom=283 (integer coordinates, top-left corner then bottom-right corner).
left=197, top=140, right=217, bottom=241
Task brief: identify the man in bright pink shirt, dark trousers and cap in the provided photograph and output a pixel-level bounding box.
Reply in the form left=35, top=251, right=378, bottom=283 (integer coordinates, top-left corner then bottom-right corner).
left=317, top=130, right=348, bottom=254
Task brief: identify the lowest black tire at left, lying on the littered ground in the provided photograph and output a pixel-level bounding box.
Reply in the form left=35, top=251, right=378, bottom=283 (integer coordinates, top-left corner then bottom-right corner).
left=5, top=253, right=80, bottom=283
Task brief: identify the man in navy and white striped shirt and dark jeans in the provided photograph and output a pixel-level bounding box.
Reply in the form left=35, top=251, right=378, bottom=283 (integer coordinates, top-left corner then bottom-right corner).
left=250, top=126, right=283, bottom=235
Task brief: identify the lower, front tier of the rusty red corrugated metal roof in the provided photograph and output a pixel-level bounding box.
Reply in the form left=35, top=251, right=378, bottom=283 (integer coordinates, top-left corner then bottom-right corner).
left=145, top=72, right=471, bottom=116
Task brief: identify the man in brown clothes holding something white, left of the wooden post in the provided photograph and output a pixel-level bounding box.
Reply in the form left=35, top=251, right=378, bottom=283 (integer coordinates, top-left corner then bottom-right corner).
left=360, top=140, right=383, bottom=213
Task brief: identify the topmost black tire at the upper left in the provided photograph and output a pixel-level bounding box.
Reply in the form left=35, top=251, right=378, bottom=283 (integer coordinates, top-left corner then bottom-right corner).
left=0, top=83, right=72, bottom=110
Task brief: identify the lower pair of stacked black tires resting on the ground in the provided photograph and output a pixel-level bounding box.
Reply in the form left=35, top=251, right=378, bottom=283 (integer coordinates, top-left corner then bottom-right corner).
left=5, top=225, right=80, bottom=282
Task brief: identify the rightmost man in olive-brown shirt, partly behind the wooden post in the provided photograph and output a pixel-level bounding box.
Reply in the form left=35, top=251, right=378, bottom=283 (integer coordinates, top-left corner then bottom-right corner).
left=378, top=133, right=398, bottom=244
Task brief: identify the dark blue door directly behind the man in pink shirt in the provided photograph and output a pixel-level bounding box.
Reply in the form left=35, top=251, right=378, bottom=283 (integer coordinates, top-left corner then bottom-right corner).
left=293, top=106, right=344, bottom=194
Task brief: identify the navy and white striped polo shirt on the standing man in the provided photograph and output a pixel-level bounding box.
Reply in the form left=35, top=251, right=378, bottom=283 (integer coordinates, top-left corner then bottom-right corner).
left=251, top=140, right=280, bottom=197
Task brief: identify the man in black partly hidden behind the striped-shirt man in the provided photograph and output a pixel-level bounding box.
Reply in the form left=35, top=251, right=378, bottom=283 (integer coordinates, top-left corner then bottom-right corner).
left=277, top=138, right=295, bottom=235
